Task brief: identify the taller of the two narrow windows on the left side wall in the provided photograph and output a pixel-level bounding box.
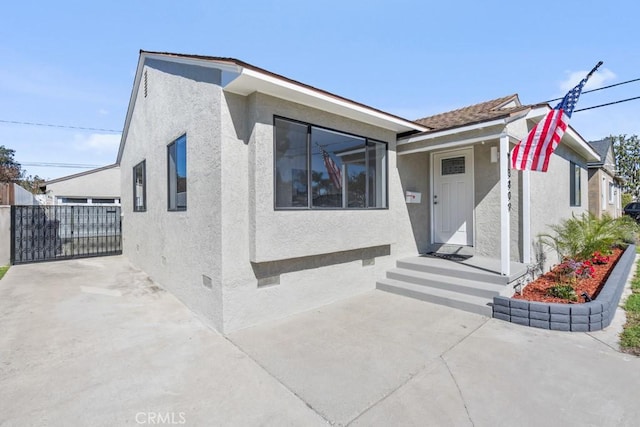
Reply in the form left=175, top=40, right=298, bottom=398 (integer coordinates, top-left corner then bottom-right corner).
left=167, top=135, right=187, bottom=211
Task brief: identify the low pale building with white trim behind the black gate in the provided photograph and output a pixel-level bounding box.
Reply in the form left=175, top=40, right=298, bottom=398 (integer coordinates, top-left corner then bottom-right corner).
left=40, top=164, right=121, bottom=205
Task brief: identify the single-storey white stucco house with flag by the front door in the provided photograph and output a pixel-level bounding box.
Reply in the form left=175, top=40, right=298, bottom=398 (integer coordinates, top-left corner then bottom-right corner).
left=117, top=51, right=596, bottom=332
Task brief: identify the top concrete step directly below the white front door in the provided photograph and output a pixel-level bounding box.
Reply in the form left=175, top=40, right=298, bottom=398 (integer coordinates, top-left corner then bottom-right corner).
left=396, top=257, right=508, bottom=285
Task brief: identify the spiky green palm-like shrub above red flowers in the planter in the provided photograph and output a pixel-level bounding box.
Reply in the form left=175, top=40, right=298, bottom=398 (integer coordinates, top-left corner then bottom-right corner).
left=540, top=213, right=639, bottom=260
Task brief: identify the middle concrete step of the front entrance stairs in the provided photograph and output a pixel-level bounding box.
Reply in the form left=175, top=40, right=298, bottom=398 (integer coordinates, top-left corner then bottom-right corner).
left=387, top=268, right=506, bottom=299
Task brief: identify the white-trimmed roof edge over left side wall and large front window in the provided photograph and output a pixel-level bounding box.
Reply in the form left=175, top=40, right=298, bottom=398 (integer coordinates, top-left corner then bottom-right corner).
left=117, top=50, right=428, bottom=163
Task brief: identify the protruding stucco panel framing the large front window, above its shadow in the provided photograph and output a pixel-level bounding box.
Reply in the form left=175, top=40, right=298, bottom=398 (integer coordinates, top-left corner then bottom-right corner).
left=249, top=94, right=408, bottom=262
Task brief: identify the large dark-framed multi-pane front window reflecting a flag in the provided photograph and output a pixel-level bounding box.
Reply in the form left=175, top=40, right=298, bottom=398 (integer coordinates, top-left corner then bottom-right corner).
left=274, top=118, right=387, bottom=209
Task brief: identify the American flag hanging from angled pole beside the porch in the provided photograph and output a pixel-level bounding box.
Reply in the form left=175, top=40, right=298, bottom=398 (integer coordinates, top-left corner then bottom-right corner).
left=511, top=61, right=602, bottom=172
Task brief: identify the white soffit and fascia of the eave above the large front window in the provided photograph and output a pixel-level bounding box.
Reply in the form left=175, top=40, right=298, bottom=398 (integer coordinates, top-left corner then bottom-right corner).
left=224, top=68, right=427, bottom=133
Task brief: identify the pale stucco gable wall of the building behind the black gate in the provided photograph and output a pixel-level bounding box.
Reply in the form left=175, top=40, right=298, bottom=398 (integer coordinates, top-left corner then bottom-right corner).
left=47, top=166, right=121, bottom=201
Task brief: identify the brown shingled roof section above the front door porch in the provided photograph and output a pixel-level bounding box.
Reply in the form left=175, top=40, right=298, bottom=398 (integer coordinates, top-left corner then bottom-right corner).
left=416, top=94, right=538, bottom=132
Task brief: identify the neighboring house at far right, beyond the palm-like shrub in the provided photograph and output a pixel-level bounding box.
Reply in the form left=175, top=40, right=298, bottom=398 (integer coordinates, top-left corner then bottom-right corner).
left=588, top=138, right=623, bottom=218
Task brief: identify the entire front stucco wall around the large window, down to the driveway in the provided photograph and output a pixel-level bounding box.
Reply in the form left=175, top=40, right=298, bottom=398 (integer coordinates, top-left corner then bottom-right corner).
left=221, top=93, right=417, bottom=332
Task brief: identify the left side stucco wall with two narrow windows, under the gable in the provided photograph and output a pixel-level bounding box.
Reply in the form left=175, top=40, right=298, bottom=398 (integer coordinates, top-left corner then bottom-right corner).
left=121, top=61, right=222, bottom=329
